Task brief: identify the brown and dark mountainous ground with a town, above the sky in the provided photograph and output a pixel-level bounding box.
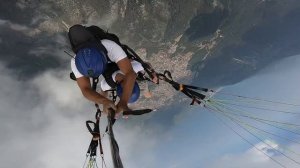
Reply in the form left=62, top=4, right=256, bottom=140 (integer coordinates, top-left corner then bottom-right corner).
left=0, top=0, right=300, bottom=107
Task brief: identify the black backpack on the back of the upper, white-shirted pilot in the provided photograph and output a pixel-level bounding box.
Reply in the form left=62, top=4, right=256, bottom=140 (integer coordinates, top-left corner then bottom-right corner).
left=68, top=25, right=154, bottom=88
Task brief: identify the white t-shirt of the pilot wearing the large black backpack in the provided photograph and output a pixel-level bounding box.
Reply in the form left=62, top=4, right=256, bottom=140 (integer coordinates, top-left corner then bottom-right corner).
left=71, top=39, right=127, bottom=78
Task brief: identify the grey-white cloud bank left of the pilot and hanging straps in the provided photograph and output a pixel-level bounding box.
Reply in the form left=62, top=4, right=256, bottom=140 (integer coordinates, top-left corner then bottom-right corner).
left=0, top=62, right=94, bottom=168
